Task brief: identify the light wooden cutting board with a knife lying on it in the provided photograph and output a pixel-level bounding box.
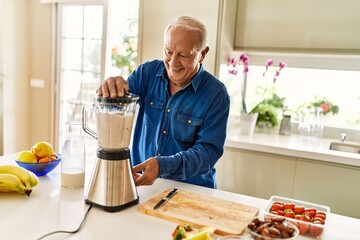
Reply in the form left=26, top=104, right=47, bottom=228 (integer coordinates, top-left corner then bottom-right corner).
left=138, top=189, right=259, bottom=235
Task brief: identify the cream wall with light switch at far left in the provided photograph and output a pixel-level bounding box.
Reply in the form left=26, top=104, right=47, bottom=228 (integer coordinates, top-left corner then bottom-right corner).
left=0, top=0, right=52, bottom=154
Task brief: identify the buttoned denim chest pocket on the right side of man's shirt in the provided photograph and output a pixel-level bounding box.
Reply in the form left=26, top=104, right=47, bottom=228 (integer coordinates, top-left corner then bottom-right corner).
left=174, top=113, right=203, bottom=142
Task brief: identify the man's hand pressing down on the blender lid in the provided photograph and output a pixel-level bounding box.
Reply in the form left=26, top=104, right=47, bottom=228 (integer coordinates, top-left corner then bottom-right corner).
left=97, top=76, right=129, bottom=98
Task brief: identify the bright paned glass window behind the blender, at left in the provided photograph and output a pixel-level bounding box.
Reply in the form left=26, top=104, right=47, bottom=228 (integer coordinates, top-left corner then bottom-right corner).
left=56, top=0, right=139, bottom=150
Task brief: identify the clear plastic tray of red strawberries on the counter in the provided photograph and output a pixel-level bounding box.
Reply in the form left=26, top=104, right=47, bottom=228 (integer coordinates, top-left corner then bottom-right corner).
left=264, top=196, right=330, bottom=239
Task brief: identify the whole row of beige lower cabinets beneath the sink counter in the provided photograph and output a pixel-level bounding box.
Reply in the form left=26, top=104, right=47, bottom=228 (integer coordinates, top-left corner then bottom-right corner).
left=216, top=147, right=360, bottom=218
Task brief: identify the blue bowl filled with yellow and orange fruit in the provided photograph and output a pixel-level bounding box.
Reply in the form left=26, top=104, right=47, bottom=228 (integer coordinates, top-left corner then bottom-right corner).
left=15, top=142, right=61, bottom=176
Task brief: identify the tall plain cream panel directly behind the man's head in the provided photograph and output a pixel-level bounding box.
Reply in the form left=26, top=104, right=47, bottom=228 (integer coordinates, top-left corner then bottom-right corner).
left=139, top=0, right=222, bottom=74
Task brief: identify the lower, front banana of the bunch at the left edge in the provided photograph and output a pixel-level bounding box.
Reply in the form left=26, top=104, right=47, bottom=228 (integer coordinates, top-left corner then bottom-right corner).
left=0, top=173, right=32, bottom=196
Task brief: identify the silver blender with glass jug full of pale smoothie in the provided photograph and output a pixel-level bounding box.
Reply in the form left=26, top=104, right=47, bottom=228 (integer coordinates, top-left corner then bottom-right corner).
left=82, top=94, right=139, bottom=212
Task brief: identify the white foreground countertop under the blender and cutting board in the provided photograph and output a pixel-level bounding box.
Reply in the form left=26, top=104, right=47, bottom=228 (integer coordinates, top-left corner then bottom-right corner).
left=0, top=154, right=360, bottom=240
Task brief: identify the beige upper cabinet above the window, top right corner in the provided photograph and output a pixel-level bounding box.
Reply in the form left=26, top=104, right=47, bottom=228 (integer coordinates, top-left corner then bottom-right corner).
left=235, top=0, right=360, bottom=54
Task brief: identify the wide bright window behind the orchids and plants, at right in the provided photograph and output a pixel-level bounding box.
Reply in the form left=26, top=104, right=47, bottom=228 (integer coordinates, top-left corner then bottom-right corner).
left=220, top=52, right=360, bottom=130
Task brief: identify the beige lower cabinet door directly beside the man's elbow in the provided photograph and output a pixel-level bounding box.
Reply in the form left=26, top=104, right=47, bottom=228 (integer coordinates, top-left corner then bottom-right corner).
left=216, top=148, right=296, bottom=199
